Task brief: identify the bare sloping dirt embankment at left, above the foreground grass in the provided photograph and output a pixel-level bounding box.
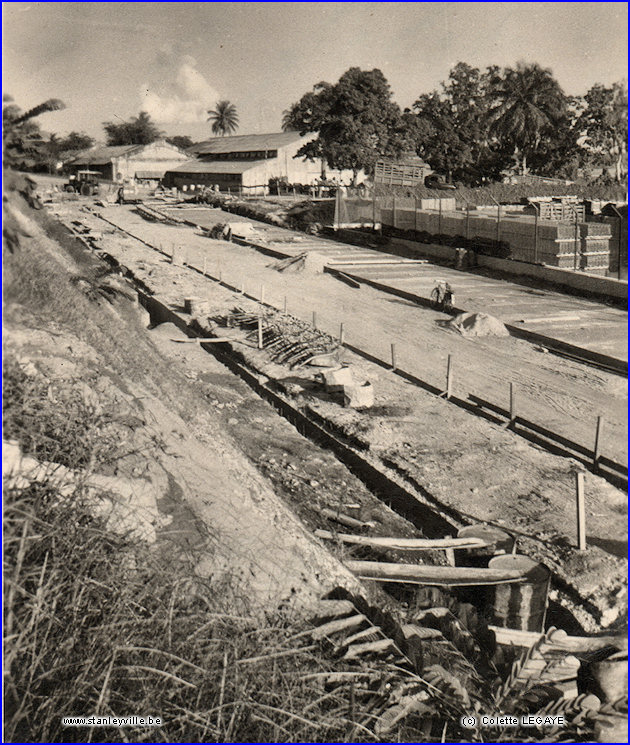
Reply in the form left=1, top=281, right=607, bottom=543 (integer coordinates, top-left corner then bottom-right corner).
left=4, top=187, right=370, bottom=607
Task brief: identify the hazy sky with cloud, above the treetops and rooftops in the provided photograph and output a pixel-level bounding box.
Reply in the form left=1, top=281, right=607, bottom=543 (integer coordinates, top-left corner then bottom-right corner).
left=3, top=2, right=628, bottom=141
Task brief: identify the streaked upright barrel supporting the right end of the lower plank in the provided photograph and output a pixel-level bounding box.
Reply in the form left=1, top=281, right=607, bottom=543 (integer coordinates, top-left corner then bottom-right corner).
left=488, top=554, right=550, bottom=632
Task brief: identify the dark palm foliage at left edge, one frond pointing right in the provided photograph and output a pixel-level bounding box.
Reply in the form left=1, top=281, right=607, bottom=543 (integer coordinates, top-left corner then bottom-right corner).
left=2, top=94, right=65, bottom=170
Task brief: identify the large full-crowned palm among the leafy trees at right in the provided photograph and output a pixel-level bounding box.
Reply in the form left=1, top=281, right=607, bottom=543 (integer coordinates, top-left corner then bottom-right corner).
left=490, top=62, right=567, bottom=173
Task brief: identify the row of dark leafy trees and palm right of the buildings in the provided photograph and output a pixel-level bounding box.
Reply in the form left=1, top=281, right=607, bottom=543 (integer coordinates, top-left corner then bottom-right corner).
left=282, top=62, right=628, bottom=186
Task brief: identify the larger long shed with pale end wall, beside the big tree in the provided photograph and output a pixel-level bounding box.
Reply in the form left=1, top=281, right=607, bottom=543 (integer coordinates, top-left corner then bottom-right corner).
left=164, top=132, right=360, bottom=194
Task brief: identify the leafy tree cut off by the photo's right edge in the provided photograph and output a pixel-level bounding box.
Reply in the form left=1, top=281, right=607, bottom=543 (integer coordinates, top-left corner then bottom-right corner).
left=577, top=83, right=628, bottom=182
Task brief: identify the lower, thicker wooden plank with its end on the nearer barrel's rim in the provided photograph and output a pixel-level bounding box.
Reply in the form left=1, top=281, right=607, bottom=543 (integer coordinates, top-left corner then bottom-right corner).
left=345, top=561, right=524, bottom=586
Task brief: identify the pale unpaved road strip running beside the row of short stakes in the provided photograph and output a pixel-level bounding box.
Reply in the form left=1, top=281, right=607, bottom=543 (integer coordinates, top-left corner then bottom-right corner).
left=87, top=202, right=627, bottom=465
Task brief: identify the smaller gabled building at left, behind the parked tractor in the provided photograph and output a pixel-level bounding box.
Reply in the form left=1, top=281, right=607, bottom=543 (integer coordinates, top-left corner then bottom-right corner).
left=65, top=140, right=189, bottom=181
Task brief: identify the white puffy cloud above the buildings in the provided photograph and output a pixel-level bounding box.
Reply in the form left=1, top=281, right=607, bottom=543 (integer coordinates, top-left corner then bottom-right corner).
left=140, top=56, right=219, bottom=124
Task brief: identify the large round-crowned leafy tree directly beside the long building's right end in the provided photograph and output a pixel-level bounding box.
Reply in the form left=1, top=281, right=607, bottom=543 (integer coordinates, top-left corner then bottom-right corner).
left=282, top=67, right=415, bottom=183
